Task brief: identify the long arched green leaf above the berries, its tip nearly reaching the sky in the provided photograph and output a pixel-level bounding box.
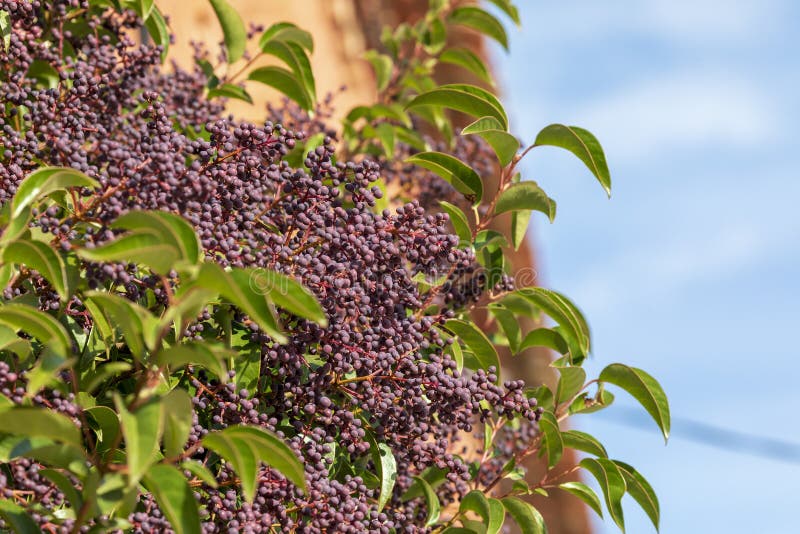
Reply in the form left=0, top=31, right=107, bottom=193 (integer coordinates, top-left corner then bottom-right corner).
left=406, top=84, right=508, bottom=130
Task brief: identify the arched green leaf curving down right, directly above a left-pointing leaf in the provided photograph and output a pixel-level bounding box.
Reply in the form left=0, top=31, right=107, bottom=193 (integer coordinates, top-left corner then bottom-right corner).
left=111, top=211, right=202, bottom=264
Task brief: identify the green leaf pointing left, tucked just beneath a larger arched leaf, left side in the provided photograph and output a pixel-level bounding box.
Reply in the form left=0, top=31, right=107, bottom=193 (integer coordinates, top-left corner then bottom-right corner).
left=77, top=232, right=179, bottom=274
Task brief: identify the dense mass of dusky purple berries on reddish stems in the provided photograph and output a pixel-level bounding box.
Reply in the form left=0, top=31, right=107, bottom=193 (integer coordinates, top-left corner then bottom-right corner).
left=0, top=0, right=539, bottom=533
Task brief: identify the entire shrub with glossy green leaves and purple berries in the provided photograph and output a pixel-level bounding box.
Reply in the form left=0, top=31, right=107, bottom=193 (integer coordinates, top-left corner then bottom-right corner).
left=0, top=0, right=670, bottom=533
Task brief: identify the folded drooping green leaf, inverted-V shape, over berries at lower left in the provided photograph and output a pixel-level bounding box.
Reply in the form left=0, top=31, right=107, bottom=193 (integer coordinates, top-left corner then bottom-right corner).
left=203, top=426, right=306, bottom=503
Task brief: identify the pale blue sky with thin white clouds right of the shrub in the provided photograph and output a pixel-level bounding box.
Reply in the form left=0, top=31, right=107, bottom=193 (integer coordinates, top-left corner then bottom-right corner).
left=495, top=0, right=800, bottom=534
